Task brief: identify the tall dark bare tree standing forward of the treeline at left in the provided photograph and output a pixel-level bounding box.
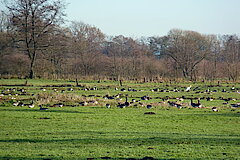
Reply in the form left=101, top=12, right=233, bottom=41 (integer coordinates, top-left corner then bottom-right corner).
left=6, top=0, right=64, bottom=78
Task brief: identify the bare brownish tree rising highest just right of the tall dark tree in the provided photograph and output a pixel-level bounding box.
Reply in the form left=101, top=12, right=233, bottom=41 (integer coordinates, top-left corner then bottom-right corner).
left=70, top=22, right=105, bottom=76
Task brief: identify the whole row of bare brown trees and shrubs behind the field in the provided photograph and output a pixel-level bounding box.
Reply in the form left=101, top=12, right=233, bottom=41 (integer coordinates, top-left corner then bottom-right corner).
left=0, top=0, right=240, bottom=81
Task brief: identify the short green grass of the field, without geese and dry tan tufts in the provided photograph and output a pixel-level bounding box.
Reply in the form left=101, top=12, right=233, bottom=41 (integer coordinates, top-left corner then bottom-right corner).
left=0, top=80, right=240, bottom=159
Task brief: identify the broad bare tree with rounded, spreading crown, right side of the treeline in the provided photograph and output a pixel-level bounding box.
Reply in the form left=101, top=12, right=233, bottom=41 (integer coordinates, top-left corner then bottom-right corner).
left=161, top=29, right=211, bottom=79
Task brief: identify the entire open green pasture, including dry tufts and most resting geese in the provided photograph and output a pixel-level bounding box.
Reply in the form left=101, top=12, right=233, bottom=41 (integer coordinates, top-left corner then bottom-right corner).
left=0, top=79, right=240, bottom=159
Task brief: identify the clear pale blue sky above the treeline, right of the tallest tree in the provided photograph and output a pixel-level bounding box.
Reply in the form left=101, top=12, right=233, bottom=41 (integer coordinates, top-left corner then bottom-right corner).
left=65, top=0, right=240, bottom=37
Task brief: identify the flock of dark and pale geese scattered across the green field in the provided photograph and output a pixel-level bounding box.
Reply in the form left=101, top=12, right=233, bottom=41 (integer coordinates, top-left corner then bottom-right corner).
left=0, top=86, right=240, bottom=112
